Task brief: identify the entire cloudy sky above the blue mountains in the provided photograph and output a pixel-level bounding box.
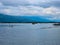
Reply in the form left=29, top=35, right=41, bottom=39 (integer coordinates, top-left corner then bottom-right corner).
left=0, top=0, right=60, bottom=17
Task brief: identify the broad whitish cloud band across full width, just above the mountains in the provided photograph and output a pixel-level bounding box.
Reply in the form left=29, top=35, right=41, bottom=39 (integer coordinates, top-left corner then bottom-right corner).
left=0, top=3, right=60, bottom=16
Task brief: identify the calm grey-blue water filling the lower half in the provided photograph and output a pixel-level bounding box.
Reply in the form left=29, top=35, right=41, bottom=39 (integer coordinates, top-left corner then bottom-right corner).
left=0, top=23, right=60, bottom=45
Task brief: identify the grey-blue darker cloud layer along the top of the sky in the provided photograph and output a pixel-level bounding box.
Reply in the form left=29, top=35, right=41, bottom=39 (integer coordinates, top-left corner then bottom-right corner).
left=0, top=0, right=60, bottom=8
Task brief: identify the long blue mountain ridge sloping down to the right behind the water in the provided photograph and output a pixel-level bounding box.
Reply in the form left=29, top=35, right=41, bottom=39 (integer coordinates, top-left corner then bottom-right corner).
left=0, top=14, right=52, bottom=23
